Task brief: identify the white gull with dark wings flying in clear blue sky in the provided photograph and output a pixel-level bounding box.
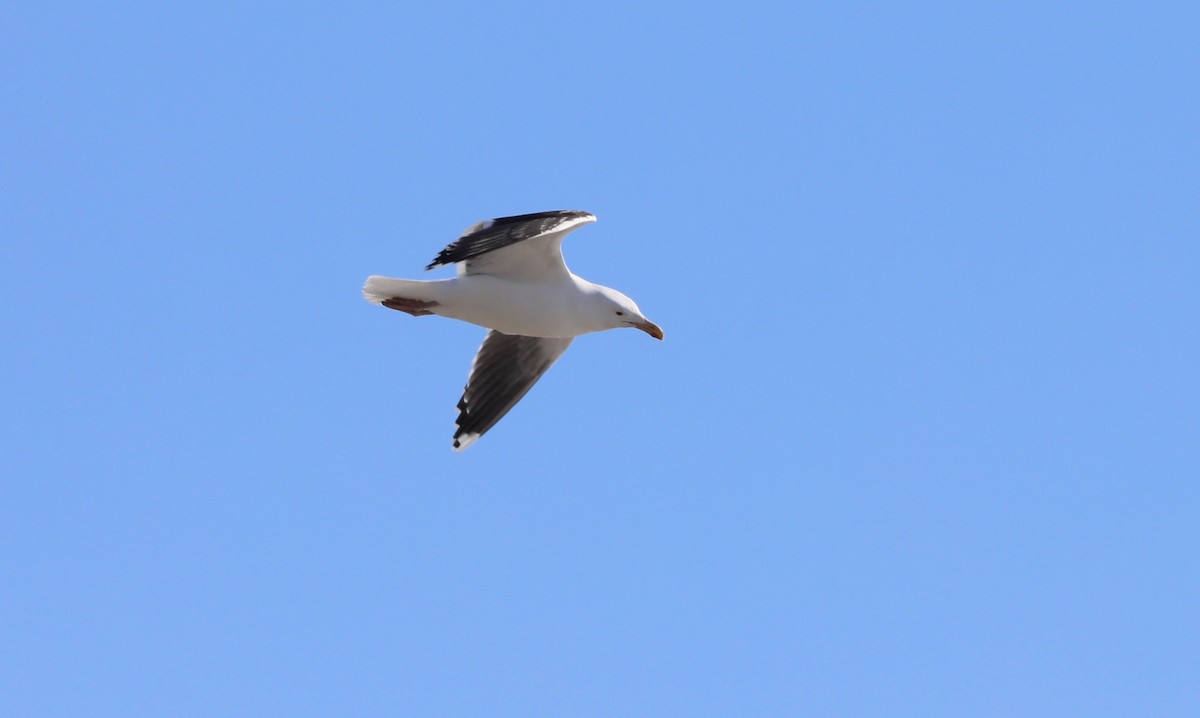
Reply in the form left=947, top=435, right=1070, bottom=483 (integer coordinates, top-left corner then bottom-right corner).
left=362, top=210, right=662, bottom=451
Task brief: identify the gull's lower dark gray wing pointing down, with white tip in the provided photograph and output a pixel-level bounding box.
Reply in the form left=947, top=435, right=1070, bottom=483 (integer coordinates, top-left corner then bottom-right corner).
left=454, top=330, right=571, bottom=451
